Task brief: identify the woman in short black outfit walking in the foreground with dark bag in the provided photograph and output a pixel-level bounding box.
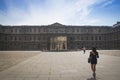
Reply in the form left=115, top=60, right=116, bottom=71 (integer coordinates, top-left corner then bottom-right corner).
left=89, top=47, right=99, bottom=77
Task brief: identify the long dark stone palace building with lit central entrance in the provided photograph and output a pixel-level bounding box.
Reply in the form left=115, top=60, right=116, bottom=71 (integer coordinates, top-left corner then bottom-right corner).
left=0, top=22, right=120, bottom=50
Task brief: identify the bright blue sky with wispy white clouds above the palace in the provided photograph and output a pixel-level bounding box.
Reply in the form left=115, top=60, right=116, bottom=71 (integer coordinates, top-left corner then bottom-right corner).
left=0, top=0, right=120, bottom=26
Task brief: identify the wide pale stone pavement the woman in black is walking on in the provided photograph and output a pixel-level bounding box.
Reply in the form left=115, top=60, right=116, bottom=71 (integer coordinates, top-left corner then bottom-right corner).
left=0, top=51, right=120, bottom=80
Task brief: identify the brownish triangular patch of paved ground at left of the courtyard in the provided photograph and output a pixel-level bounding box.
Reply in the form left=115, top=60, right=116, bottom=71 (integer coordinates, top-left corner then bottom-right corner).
left=0, top=51, right=39, bottom=72
